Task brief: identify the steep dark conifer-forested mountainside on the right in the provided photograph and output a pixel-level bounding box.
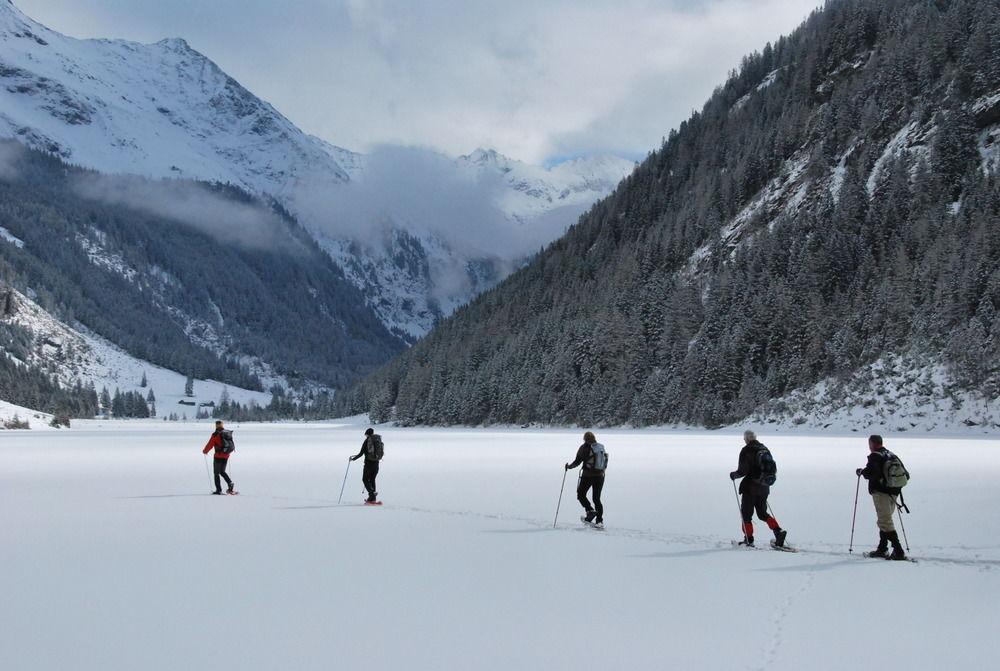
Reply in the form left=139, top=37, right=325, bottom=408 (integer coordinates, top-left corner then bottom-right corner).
left=338, top=0, right=1000, bottom=426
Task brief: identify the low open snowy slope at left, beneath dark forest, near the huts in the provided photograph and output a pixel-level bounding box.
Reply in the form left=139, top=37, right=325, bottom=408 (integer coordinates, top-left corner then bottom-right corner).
left=0, top=292, right=272, bottom=417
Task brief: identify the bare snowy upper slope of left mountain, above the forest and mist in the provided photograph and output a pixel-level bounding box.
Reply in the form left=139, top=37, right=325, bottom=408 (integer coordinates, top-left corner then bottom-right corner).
left=0, top=2, right=354, bottom=197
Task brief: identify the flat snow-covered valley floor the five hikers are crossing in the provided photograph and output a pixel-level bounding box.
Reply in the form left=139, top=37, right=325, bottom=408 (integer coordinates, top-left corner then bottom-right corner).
left=0, top=421, right=1000, bottom=671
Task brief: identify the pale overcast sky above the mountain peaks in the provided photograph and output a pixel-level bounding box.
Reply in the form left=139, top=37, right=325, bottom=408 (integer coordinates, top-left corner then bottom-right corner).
left=15, top=0, right=819, bottom=163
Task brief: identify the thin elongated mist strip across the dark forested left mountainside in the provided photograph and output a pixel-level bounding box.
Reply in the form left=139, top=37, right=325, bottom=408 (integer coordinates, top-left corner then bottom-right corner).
left=73, top=174, right=293, bottom=248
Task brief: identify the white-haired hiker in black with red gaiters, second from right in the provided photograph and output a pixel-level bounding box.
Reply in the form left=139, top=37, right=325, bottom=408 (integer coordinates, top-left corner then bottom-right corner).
left=729, top=431, right=791, bottom=550
